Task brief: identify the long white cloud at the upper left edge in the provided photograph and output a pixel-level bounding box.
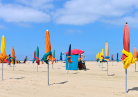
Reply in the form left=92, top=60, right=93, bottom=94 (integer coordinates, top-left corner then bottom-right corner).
left=0, top=0, right=51, bottom=23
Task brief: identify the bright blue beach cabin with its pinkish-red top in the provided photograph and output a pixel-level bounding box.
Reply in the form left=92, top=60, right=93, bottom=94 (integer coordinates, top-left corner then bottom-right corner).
left=65, top=49, right=84, bottom=70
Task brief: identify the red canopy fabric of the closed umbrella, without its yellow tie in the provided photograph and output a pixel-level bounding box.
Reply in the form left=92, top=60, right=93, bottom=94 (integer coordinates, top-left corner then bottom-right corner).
left=121, top=23, right=130, bottom=60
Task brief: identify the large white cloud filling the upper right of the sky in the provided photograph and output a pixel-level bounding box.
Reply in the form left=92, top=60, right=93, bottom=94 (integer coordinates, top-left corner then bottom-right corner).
left=53, top=0, right=138, bottom=25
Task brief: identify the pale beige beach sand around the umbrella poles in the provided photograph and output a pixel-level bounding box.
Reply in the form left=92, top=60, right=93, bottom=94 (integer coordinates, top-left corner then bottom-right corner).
left=0, top=62, right=138, bottom=97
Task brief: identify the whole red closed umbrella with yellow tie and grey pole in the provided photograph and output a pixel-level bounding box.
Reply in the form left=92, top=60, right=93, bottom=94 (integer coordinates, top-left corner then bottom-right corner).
left=121, top=23, right=136, bottom=93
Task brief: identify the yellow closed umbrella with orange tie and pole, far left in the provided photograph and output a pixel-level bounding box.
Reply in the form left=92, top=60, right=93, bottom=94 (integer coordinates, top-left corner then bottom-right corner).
left=0, top=35, right=7, bottom=80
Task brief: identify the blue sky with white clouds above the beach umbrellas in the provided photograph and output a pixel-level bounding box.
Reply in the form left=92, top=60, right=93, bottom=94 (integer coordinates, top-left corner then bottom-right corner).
left=0, top=0, right=138, bottom=60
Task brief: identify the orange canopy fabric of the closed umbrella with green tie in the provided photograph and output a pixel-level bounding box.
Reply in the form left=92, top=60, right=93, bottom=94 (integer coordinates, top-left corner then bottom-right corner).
left=45, top=30, right=52, bottom=60
